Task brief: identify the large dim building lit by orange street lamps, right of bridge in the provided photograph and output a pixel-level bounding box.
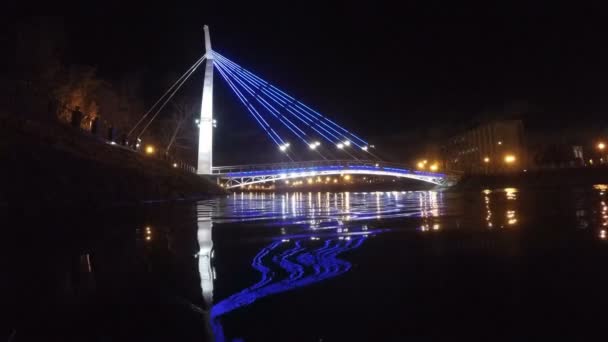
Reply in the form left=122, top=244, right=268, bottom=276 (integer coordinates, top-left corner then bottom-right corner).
left=441, top=120, right=527, bottom=174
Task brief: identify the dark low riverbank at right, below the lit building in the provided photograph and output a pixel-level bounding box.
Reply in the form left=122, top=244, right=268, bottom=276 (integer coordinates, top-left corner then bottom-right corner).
left=452, top=167, right=608, bottom=190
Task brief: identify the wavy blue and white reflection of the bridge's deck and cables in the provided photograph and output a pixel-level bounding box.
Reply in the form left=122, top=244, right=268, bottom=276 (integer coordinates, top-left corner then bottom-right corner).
left=199, top=191, right=443, bottom=341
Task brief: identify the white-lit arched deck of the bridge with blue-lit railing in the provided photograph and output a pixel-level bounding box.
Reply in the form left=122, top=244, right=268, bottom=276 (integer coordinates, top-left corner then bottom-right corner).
left=212, top=160, right=458, bottom=189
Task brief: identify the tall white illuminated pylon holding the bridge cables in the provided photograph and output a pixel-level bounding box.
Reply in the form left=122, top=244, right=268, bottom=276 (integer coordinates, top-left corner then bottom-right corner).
left=196, top=25, right=213, bottom=175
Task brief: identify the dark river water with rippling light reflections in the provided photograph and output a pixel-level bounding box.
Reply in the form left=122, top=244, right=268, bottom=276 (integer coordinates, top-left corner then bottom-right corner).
left=2, top=184, right=608, bottom=341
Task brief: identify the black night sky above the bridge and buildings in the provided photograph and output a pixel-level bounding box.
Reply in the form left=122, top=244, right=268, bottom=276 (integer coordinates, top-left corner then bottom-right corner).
left=10, top=1, right=608, bottom=163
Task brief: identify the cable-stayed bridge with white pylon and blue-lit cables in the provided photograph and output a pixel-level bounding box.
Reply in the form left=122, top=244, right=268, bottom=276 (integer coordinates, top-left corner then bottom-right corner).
left=129, top=26, right=456, bottom=188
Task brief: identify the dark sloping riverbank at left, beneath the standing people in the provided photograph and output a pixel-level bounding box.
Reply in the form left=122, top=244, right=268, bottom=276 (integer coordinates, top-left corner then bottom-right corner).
left=0, top=115, right=224, bottom=206
